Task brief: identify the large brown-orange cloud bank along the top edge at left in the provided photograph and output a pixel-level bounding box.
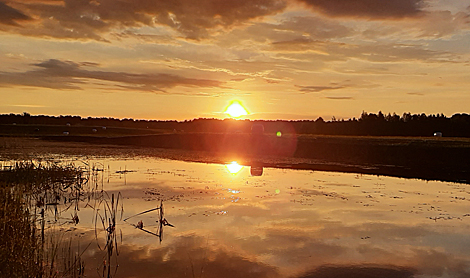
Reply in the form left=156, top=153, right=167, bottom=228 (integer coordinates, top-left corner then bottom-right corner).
left=2, top=0, right=286, bottom=40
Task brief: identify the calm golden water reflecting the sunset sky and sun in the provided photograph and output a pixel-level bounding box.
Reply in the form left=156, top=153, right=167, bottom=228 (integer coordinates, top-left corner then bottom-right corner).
left=28, top=158, right=470, bottom=278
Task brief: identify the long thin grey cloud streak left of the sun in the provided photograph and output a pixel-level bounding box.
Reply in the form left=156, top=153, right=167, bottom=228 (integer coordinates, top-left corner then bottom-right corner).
left=0, top=59, right=226, bottom=92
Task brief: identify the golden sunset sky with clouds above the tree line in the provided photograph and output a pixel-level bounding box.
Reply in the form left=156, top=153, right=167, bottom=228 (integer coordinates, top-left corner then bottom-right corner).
left=0, top=0, right=470, bottom=120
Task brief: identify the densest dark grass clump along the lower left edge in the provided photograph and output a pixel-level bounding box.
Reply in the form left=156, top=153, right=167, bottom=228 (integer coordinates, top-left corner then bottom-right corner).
left=0, top=162, right=83, bottom=277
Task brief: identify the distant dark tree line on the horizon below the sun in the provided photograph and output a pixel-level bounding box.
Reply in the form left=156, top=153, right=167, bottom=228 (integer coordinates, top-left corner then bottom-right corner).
left=0, top=111, right=470, bottom=137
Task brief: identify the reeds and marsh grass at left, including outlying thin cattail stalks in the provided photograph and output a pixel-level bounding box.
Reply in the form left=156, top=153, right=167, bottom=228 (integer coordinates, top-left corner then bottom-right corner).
left=0, top=161, right=123, bottom=277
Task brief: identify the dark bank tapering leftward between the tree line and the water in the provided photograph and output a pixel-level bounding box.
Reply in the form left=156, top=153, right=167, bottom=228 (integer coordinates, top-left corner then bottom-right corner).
left=37, top=133, right=470, bottom=183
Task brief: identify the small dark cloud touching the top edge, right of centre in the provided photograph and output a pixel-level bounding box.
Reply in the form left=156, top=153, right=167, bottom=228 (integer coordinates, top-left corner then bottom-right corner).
left=298, top=0, right=424, bottom=19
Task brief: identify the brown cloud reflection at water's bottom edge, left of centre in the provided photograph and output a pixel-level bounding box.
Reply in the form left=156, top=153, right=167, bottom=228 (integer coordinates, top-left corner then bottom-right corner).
left=82, top=236, right=281, bottom=278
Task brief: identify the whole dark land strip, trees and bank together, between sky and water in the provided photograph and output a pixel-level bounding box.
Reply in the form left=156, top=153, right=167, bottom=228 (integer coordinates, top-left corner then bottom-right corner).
left=0, top=112, right=470, bottom=183
